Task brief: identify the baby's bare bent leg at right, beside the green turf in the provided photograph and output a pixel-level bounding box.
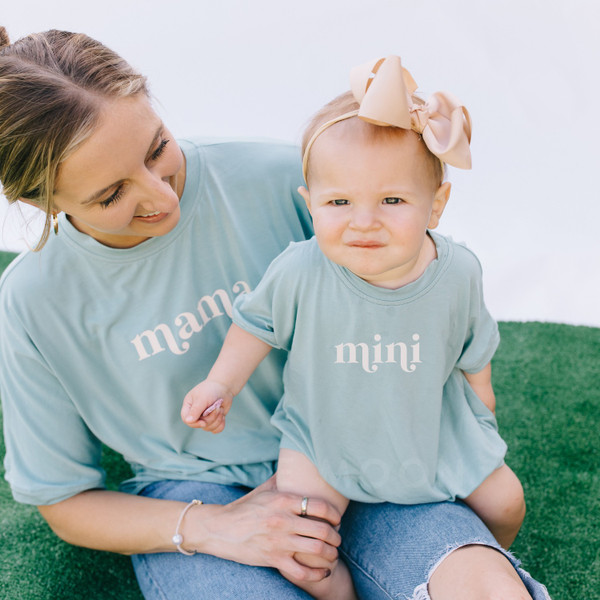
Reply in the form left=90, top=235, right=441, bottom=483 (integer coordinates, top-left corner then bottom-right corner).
left=464, top=465, right=525, bottom=549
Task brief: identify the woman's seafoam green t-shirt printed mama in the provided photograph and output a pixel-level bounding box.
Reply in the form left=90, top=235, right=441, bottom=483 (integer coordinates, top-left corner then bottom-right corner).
left=0, top=141, right=312, bottom=504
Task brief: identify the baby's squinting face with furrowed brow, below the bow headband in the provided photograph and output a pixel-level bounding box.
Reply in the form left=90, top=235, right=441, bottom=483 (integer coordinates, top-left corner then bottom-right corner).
left=304, top=126, right=450, bottom=289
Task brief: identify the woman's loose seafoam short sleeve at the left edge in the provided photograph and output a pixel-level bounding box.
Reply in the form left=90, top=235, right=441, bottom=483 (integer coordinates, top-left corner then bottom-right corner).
left=0, top=302, right=104, bottom=505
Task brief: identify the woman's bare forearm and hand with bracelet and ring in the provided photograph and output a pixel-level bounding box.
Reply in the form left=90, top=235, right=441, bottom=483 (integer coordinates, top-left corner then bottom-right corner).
left=38, top=479, right=341, bottom=581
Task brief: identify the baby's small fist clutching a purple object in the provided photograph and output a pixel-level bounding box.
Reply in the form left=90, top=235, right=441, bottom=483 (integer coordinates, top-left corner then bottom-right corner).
left=181, top=379, right=233, bottom=433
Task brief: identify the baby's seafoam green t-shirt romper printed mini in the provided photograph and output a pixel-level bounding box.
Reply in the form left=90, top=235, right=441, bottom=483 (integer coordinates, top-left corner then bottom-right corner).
left=233, top=232, right=506, bottom=504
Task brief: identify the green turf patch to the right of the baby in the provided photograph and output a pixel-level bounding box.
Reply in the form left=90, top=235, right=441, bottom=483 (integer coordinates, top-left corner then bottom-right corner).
left=494, top=323, right=600, bottom=600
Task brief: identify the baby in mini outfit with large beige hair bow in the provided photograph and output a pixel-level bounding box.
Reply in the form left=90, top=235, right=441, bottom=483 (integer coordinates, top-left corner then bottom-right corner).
left=182, top=56, right=525, bottom=599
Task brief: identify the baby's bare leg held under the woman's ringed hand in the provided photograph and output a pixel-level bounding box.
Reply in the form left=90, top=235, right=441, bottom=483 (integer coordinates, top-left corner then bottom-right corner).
left=276, top=448, right=357, bottom=600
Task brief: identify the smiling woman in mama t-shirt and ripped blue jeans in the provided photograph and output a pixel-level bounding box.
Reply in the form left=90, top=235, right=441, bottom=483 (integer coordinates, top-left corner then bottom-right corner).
left=0, top=25, right=547, bottom=600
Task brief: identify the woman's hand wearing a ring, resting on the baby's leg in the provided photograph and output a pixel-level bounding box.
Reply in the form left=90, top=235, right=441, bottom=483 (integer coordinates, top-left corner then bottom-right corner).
left=192, top=478, right=341, bottom=581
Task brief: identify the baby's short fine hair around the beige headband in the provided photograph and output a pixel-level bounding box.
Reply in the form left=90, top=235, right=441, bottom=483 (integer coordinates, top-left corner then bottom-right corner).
left=302, top=91, right=445, bottom=185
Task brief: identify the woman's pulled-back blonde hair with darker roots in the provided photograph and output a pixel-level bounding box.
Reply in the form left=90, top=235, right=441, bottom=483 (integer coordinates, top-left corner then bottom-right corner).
left=0, top=27, right=148, bottom=250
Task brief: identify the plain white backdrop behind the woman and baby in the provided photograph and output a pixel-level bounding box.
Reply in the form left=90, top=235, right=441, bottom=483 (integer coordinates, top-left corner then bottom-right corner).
left=0, top=0, right=600, bottom=326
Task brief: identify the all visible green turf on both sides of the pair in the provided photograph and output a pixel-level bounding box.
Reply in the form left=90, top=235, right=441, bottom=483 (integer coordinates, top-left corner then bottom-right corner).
left=0, top=253, right=600, bottom=600
